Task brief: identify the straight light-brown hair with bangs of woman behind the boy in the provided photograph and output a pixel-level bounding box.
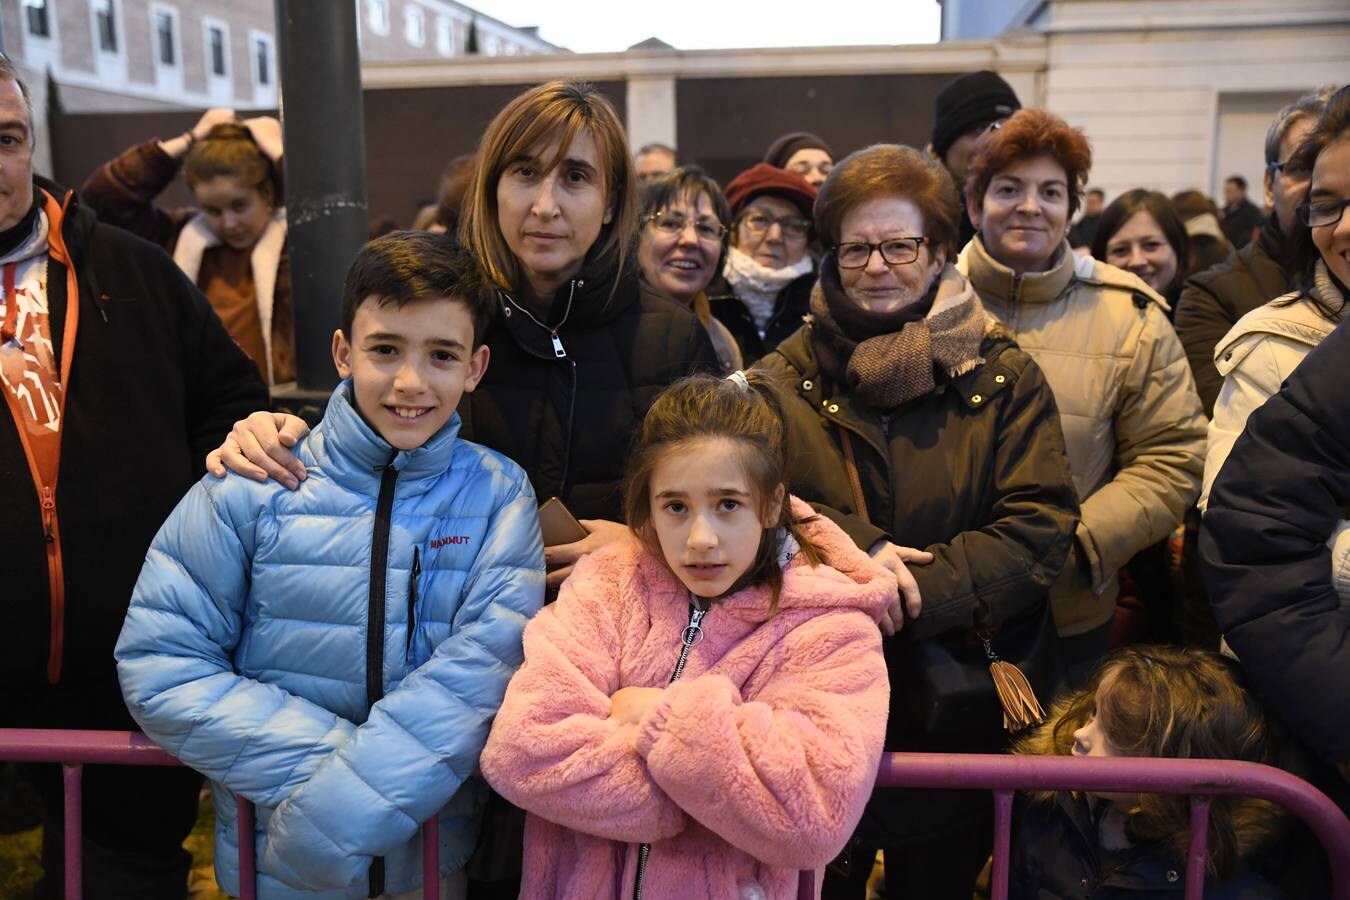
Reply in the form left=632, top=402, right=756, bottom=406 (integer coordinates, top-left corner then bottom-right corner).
left=459, top=81, right=637, bottom=290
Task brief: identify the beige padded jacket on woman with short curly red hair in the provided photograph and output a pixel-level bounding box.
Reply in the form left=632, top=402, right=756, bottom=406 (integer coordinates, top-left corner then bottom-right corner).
left=957, top=236, right=1206, bottom=637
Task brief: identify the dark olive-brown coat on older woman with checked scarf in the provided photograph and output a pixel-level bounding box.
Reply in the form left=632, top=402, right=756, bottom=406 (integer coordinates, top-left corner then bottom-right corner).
left=760, top=324, right=1079, bottom=846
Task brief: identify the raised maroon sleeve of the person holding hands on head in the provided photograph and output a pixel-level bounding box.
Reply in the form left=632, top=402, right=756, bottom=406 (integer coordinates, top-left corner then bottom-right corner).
left=80, top=140, right=193, bottom=250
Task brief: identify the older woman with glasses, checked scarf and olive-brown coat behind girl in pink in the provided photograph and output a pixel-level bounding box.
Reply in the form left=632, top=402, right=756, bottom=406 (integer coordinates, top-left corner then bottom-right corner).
left=760, top=144, right=1077, bottom=900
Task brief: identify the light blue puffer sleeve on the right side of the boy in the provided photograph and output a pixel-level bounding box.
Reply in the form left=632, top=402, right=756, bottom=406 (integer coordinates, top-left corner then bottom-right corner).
left=262, top=467, right=544, bottom=889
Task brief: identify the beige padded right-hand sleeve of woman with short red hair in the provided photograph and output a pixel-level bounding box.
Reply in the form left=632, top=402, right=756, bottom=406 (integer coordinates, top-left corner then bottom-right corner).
left=1079, top=298, right=1206, bottom=586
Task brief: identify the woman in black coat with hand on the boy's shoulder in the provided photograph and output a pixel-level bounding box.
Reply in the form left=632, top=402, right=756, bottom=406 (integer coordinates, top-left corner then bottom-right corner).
left=208, top=81, right=718, bottom=587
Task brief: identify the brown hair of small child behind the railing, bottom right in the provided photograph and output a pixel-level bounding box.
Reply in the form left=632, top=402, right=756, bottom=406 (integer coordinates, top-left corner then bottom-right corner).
left=1014, top=646, right=1281, bottom=880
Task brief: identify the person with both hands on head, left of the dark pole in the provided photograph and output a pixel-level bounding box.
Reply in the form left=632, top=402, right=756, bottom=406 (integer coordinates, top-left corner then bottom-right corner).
left=80, top=108, right=296, bottom=385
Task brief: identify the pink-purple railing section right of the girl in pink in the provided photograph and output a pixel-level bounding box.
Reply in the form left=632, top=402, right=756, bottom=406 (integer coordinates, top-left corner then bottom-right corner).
left=798, top=753, right=1350, bottom=900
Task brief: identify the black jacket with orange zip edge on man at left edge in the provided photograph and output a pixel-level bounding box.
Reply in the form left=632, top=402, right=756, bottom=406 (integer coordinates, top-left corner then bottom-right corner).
left=0, top=178, right=267, bottom=690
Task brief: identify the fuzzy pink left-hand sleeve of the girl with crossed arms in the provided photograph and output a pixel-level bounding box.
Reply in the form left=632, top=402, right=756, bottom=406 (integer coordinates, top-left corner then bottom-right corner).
left=482, top=555, right=685, bottom=842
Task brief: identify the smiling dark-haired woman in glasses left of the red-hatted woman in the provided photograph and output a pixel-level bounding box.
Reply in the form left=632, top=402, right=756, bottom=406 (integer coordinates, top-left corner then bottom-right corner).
left=637, top=166, right=743, bottom=372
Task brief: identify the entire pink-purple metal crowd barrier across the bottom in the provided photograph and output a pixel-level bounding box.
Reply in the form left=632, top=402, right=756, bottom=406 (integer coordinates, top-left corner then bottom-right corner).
left=0, top=729, right=1350, bottom=900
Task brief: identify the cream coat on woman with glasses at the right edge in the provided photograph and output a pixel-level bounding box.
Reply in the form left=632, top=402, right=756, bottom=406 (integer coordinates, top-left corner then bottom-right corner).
left=1200, top=262, right=1350, bottom=603
